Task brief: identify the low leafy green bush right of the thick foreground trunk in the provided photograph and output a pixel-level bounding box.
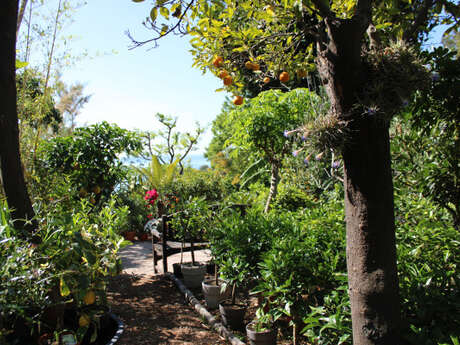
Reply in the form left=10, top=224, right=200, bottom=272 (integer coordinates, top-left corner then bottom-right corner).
left=396, top=197, right=460, bottom=345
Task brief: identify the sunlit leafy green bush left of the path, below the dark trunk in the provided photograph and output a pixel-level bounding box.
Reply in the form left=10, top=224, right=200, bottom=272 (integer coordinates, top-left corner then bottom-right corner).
left=0, top=201, right=128, bottom=344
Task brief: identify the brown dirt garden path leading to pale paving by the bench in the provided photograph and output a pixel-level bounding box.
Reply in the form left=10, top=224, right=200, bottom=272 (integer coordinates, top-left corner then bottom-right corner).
left=108, top=242, right=228, bottom=345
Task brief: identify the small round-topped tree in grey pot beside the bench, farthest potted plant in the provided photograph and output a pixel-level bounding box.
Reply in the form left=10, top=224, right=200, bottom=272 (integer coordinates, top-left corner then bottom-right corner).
left=171, top=197, right=210, bottom=288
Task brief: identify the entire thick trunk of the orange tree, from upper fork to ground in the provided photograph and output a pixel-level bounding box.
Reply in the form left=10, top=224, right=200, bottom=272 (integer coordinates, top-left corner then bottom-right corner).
left=317, top=17, right=400, bottom=345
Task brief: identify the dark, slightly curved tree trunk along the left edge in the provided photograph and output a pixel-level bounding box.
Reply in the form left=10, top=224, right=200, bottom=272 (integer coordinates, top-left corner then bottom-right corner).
left=0, top=0, right=35, bottom=231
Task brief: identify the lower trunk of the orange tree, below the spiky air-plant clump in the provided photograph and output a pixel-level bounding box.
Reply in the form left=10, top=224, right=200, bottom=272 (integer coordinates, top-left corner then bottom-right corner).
left=343, top=120, right=400, bottom=345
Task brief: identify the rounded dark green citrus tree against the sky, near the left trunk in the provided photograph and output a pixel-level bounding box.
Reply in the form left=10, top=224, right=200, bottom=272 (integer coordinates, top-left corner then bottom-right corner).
left=37, top=122, right=141, bottom=204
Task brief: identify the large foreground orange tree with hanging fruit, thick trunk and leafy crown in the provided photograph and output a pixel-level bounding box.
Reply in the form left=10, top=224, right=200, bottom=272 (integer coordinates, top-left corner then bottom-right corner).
left=141, top=0, right=460, bottom=344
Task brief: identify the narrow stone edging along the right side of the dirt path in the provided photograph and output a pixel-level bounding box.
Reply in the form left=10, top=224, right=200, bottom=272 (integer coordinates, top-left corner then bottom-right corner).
left=165, top=273, right=246, bottom=345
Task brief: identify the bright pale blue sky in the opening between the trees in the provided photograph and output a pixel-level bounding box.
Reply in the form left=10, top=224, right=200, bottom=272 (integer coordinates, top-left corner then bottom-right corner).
left=41, top=0, right=225, bottom=151
